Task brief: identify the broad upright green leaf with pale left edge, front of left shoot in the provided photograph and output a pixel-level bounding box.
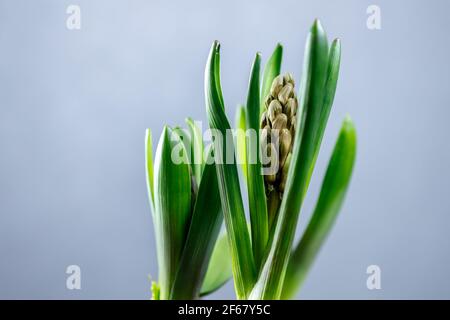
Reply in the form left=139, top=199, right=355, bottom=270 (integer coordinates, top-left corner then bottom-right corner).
left=154, top=126, right=191, bottom=300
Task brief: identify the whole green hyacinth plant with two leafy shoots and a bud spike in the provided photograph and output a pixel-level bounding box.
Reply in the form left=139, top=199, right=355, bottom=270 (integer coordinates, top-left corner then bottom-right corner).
left=146, top=20, right=356, bottom=299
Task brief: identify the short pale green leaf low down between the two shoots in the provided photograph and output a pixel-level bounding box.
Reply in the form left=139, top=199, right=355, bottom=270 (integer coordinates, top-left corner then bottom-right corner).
left=200, top=232, right=233, bottom=296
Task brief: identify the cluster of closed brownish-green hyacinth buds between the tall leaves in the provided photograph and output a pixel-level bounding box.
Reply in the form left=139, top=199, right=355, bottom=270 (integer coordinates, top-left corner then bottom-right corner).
left=260, top=73, right=298, bottom=193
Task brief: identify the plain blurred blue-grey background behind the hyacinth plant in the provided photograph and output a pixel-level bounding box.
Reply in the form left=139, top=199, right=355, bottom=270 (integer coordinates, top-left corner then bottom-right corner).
left=0, top=0, right=450, bottom=299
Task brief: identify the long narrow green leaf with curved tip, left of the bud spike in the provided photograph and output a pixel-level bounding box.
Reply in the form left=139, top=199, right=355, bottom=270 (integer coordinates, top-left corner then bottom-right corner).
left=205, top=41, right=256, bottom=299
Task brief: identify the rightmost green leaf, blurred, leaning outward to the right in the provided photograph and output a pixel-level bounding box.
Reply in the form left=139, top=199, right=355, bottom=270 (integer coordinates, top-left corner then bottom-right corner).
left=282, top=117, right=356, bottom=299
